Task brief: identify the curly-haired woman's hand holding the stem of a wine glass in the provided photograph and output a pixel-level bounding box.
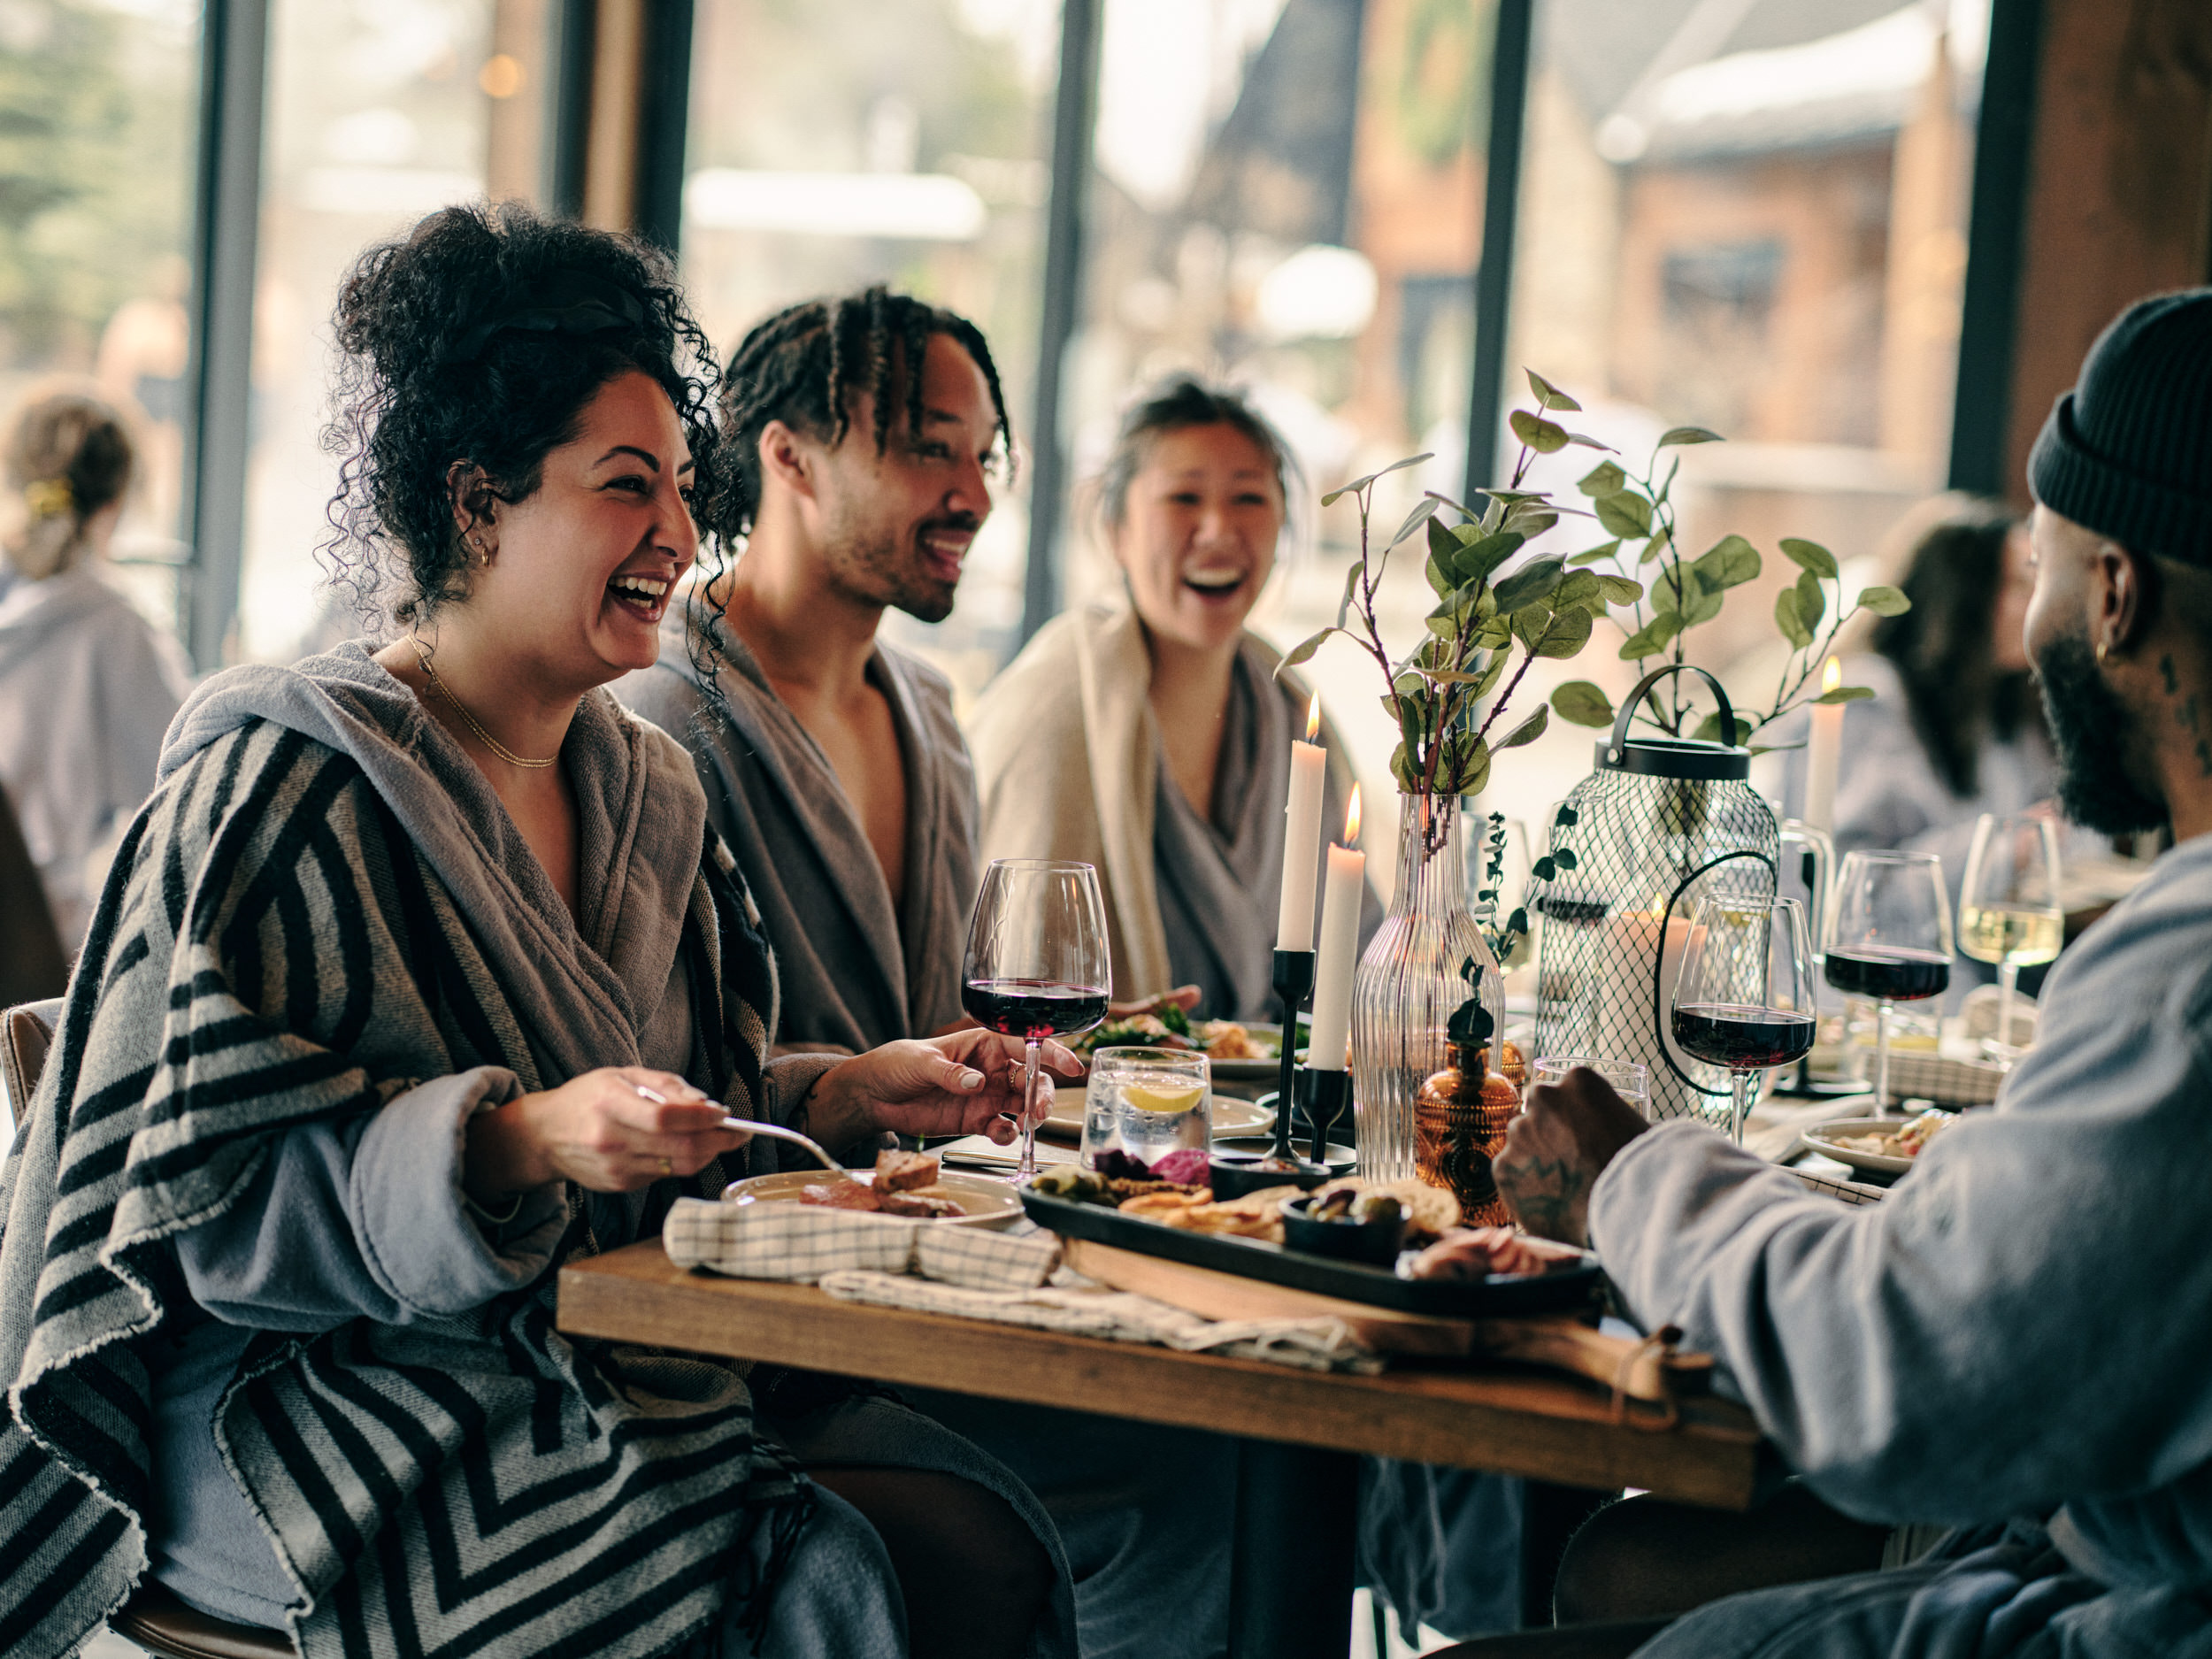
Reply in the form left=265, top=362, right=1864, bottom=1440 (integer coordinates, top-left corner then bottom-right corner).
left=805, top=1026, right=1084, bottom=1148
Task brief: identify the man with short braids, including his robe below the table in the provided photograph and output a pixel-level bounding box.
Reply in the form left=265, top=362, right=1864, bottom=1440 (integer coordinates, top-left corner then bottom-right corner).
left=619, top=288, right=1234, bottom=1659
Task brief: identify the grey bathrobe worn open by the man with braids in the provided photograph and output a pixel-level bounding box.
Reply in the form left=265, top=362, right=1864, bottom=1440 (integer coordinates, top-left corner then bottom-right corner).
left=615, top=597, right=976, bottom=1053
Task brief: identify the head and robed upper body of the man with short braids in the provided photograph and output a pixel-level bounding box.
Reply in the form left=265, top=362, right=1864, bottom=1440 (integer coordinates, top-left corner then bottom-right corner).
left=622, top=288, right=1011, bottom=1051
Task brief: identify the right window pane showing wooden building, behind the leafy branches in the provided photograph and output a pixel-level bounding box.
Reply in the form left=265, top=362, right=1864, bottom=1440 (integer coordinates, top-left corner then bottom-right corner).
left=1504, top=0, right=1989, bottom=812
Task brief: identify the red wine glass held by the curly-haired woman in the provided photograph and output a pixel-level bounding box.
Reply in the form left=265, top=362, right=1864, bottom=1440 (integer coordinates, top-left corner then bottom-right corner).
left=960, top=858, right=1113, bottom=1184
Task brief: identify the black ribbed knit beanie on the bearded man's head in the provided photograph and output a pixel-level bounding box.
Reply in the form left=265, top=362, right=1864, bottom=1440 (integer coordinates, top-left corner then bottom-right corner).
left=2029, top=288, right=2212, bottom=565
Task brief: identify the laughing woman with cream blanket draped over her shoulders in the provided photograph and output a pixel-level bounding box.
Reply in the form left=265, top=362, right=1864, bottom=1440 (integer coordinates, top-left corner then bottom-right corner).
left=969, top=376, right=1380, bottom=1020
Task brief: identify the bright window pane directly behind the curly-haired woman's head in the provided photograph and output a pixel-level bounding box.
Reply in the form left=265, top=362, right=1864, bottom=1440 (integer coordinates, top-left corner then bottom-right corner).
left=233, top=0, right=553, bottom=659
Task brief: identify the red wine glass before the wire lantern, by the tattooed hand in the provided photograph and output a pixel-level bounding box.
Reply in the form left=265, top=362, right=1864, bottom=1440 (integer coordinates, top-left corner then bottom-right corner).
left=1675, top=896, right=1818, bottom=1144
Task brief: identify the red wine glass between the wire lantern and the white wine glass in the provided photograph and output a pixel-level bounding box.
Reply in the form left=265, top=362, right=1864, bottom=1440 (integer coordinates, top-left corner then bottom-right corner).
left=1827, top=852, right=1951, bottom=1118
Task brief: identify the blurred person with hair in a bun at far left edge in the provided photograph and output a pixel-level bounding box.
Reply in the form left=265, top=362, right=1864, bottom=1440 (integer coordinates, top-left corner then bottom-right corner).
left=0, top=380, right=190, bottom=954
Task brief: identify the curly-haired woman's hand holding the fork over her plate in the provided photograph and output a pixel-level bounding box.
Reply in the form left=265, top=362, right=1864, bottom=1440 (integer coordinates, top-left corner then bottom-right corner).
left=463, top=1066, right=752, bottom=1206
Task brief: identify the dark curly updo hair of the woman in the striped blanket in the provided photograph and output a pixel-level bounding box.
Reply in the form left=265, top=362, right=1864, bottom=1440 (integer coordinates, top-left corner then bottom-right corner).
left=319, top=202, right=721, bottom=626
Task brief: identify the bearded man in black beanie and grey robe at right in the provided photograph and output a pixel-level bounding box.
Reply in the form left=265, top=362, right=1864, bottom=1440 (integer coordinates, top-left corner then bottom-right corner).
left=1469, top=290, right=2212, bottom=1659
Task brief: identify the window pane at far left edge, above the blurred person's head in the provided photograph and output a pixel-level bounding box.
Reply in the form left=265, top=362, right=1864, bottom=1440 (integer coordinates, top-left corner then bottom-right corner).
left=0, top=0, right=199, bottom=622
